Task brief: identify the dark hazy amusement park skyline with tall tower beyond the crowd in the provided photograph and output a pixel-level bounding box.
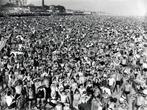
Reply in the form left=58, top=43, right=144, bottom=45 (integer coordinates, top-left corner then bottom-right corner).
left=0, top=0, right=92, bottom=15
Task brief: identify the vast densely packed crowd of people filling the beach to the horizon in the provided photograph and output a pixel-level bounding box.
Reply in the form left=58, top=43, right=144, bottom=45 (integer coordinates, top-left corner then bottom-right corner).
left=0, top=15, right=147, bottom=110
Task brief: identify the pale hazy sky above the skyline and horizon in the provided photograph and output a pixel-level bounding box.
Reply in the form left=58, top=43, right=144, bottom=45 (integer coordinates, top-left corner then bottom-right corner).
left=1, top=0, right=147, bottom=16
